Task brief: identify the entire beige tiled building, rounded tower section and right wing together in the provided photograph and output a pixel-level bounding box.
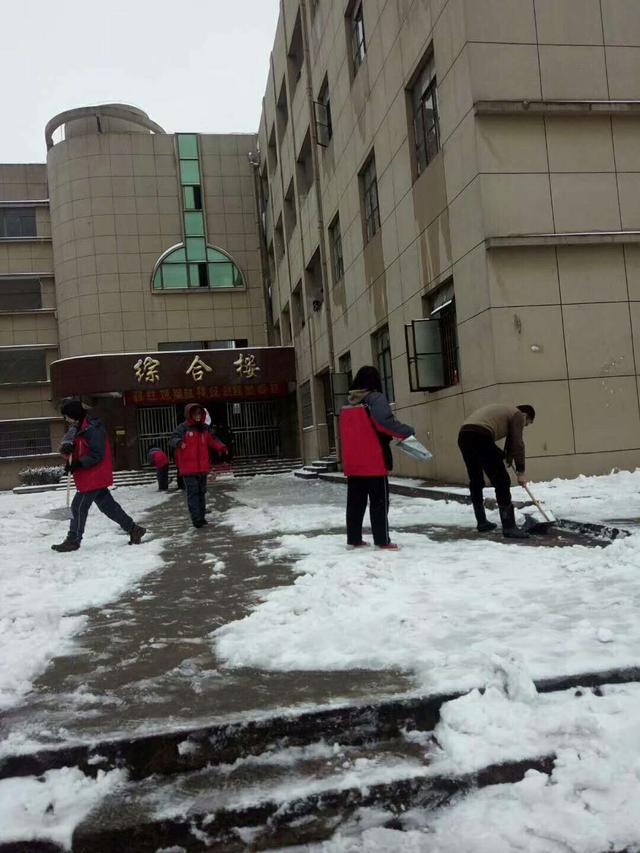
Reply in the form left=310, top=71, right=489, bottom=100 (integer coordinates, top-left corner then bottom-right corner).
left=0, top=0, right=640, bottom=485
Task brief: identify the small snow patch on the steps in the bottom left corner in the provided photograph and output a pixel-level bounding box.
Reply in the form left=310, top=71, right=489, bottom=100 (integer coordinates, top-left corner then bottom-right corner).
left=0, top=767, right=126, bottom=850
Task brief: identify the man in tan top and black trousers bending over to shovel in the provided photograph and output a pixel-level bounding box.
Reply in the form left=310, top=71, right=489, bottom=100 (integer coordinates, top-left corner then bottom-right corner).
left=458, top=403, right=536, bottom=539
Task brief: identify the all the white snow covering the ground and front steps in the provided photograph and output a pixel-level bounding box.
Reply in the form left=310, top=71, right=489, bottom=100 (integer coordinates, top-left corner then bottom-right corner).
left=0, top=472, right=640, bottom=853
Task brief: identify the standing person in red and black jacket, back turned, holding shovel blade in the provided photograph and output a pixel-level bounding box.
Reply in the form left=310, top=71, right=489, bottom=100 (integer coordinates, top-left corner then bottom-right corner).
left=339, top=367, right=415, bottom=550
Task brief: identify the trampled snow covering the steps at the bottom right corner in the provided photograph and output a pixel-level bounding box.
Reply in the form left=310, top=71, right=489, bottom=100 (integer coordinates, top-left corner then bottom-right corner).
left=308, top=680, right=640, bottom=853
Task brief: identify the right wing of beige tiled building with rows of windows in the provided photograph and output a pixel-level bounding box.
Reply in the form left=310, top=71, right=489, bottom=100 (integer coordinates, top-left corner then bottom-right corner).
left=259, top=0, right=640, bottom=481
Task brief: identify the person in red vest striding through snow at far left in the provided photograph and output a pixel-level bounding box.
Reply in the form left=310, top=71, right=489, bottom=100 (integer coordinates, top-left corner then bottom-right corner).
left=51, top=400, right=147, bottom=553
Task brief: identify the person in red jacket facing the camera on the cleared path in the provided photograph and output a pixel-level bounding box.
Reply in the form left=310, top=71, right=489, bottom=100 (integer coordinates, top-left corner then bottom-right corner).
left=169, top=403, right=227, bottom=527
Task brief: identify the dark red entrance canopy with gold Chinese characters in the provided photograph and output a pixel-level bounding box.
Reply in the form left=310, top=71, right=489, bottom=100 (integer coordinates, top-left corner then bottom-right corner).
left=51, top=347, right=296, bottom=403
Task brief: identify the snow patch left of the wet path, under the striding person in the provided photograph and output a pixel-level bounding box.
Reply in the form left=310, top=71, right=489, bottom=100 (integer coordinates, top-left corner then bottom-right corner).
left=0, top=488, right=165, bottom=709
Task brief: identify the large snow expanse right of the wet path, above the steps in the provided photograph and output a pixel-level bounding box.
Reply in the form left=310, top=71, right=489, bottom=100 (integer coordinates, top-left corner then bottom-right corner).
left=213, top=533, right=640, bottom=691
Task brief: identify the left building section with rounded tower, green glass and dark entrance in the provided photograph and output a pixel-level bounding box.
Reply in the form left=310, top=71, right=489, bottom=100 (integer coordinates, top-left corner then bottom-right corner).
left=0, top=105, right=297, bottom=487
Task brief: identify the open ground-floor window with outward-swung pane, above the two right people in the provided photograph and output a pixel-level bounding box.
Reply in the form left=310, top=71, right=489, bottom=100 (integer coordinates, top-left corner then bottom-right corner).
left=405, top=280, right=460, bottom=391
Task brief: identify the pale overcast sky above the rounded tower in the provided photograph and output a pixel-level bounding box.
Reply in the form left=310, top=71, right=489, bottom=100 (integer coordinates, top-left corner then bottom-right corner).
left=0, top=0, right=279, bottom=163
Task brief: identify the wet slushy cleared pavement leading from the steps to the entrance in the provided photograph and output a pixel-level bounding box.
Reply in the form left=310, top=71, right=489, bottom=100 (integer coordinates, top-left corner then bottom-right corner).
left=0, top=481, right=602, bottom=745
